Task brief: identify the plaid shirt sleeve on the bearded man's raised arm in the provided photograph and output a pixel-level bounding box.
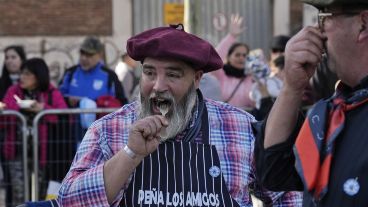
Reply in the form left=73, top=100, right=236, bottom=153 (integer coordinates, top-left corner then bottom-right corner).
left=58, top=124, right=124, bottom=207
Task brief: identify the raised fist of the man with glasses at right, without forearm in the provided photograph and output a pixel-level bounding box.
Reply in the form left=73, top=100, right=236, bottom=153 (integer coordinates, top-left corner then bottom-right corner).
left=284, top=26, right=326, bottom=94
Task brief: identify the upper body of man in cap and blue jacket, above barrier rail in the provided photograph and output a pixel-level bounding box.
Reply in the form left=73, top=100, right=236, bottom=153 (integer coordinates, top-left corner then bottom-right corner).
left=59, top=36, right=127, bottom=108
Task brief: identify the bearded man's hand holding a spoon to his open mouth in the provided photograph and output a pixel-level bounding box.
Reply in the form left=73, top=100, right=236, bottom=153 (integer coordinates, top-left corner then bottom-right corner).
left=128, top=115, right=168, bottom=159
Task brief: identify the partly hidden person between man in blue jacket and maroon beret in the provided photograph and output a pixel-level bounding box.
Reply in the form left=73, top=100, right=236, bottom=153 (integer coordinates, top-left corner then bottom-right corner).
left=115, top=53, right=139, bottom=102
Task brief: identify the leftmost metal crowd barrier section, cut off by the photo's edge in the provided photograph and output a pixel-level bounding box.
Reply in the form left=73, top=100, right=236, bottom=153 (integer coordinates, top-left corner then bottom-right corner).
left=0, top=110, right=30, bottom=206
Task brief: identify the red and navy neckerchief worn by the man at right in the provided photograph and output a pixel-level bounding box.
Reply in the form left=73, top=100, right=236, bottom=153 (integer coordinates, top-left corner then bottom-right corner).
left=295, top=89, right=368, bottom=199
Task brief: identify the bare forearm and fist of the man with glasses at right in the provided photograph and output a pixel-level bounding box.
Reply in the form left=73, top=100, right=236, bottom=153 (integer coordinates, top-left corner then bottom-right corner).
left=264, top=27, right=325, bottom=148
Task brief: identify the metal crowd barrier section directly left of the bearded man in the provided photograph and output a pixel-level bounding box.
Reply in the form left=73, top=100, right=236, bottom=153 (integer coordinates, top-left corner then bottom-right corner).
left=31, top=108, right=118, bottom=201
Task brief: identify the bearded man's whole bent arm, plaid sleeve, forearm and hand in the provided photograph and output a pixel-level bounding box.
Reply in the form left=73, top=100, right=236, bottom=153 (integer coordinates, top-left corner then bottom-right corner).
left=58, top=115, right=167, bottom=206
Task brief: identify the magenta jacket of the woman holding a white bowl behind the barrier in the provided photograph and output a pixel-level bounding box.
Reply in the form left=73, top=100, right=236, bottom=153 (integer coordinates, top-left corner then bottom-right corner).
left=3, top=84, right=67, bottom=166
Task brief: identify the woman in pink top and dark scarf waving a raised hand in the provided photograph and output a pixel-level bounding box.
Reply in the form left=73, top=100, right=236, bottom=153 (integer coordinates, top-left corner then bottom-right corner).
left=211, top=15, right=255, bottom=110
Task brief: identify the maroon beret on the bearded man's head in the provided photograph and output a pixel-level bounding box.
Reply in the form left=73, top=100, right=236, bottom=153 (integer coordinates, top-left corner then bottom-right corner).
left=127, top=24, right=223, bottom=73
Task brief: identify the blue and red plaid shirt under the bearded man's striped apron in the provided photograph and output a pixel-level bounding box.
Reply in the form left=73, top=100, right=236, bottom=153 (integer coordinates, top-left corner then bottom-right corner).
left=58, top=100, right=302, bottom=207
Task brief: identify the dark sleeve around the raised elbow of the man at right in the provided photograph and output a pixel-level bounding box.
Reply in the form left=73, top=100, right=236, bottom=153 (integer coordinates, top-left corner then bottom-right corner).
left=252, top=116, right=303, bottom=191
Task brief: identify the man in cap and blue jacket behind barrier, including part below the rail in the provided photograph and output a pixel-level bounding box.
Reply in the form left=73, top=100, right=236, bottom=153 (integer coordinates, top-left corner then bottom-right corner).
left=59, top=36, right=128, bottom=144
